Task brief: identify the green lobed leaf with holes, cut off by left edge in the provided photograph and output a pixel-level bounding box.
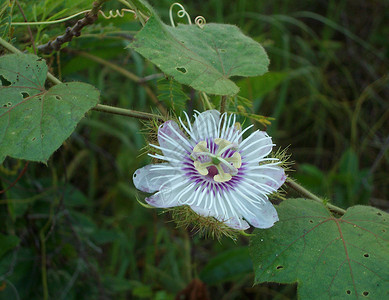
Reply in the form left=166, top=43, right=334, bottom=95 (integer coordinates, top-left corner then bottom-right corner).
left=0, top=54, right=99, bottom=163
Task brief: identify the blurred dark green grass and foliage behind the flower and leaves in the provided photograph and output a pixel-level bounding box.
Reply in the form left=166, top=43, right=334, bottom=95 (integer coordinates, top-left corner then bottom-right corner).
left=0, top=0, right=389, bottom=300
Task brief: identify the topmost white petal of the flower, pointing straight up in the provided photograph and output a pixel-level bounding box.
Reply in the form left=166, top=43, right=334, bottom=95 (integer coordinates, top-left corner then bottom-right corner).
left=192, top=109, right=220, bottom=142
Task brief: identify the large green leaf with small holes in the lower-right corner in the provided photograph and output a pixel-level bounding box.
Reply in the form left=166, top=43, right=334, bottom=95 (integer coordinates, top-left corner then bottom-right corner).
left=250, top=199, right=389, bottom=299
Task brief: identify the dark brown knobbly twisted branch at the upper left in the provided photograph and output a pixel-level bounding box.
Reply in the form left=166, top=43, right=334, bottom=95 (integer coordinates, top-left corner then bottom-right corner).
left=38, top=0, right=109, bottom=54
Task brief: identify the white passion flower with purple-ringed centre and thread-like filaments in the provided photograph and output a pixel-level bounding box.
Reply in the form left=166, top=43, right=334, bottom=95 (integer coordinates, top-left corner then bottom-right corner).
left=133, top=110, right=286, bottom=230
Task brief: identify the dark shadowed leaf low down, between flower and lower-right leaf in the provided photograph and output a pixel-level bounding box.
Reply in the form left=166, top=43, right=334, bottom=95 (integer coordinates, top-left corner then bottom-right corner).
left=200, top=247, right=253, bottom=285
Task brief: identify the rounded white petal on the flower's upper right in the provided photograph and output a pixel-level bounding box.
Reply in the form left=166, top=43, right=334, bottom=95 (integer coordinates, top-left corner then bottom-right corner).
left=239, top=131, right=274, bottom=163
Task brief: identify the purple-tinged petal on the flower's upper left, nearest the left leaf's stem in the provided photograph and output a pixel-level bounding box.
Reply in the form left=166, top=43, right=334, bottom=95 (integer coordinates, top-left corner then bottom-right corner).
left=158, top=121, right=190, bottom=156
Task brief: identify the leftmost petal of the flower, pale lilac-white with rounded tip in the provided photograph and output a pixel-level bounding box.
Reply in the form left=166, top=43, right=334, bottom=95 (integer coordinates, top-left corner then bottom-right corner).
left=132, top=164, right=182, bottom=193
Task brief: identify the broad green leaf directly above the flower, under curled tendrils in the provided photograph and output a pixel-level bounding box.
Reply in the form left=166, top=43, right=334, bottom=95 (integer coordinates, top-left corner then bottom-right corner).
left=129, top=16, right=269, bottom=95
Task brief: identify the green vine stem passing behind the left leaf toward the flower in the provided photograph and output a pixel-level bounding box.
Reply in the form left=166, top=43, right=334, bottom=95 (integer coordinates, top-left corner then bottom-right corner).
left=0, top=37, right=164, bottom=121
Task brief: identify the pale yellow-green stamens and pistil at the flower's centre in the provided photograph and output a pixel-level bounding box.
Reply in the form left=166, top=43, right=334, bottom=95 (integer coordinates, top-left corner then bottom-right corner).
left=191, top=138, right=242, bottom=182
